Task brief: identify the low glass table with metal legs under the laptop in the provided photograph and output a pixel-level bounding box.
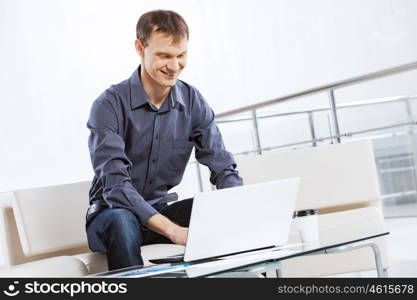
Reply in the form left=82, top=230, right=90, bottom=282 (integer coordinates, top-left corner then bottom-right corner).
left=92, top=232, right=389, bottom=278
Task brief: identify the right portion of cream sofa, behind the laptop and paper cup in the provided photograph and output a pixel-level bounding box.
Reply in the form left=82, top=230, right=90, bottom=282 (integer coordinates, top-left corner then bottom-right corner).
left=237, top=140, right=389, bottom=277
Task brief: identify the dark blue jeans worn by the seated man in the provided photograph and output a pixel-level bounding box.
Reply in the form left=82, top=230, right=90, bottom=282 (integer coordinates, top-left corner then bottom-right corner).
left=87, top=199, right=193, bottom=271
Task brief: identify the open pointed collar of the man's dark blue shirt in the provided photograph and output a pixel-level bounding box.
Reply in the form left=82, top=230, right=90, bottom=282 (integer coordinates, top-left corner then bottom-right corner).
left=129, top=65, right=184, bottom=110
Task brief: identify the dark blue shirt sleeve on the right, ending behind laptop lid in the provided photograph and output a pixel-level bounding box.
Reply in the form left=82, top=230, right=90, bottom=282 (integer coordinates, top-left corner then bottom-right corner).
left=192, top=89, right=243, bottom=189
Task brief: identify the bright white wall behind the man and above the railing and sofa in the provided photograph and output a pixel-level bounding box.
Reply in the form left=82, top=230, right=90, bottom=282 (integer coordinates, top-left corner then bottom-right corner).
left=0, top=0, right=417, bottom=191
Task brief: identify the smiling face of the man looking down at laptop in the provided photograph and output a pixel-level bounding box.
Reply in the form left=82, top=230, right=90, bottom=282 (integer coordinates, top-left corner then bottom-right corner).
left=136, top=31, right=188, bottom=87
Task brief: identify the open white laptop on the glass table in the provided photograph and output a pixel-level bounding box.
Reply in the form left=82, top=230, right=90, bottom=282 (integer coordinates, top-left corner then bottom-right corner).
left=150, top=178, right=300, bottom=263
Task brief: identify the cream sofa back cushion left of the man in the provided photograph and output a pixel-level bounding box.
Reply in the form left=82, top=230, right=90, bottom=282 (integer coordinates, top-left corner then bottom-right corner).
left=13, top=182, right=91, bottom=256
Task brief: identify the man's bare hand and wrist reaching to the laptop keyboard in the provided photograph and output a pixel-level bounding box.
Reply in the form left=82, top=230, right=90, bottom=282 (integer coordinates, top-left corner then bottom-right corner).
left=145, top=214, right=188, bottom=246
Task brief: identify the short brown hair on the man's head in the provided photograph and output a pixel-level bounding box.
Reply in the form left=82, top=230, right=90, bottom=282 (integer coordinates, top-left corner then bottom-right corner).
left=136, top=10, right=189, bottom=46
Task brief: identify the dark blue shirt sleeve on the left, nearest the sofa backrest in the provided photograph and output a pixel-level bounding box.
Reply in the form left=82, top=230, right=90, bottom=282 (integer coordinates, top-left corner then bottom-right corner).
left=87, top=100, right=158, bottom=224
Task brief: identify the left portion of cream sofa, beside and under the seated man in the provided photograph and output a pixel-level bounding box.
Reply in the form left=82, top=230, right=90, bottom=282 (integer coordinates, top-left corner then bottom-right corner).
left=0, top=182, right=184, bottom=277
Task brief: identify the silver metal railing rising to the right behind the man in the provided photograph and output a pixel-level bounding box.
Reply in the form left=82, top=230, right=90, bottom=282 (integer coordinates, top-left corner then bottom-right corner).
left=185, top=62, right=417, bottom=195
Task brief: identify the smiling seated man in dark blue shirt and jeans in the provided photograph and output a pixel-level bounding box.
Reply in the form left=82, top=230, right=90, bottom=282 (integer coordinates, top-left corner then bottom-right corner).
left=86, top=10, right=242, bottom=270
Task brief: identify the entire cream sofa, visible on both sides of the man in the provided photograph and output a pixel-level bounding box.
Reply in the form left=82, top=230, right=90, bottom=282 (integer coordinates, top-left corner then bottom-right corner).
left=0, top=140, right=389, bottom=277
